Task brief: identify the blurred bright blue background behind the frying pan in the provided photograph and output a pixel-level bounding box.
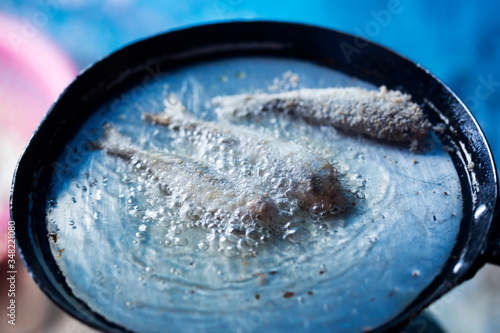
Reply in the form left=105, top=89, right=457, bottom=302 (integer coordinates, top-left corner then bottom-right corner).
left=0, top=0, right=500, bottom=332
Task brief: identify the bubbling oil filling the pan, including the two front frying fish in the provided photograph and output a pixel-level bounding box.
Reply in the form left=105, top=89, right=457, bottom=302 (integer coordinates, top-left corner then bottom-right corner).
left=46, top=57, right=463, bottom=332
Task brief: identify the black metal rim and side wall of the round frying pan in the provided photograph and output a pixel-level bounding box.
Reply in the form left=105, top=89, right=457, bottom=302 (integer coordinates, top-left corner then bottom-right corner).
left=10, top=21, right=500, bottom=332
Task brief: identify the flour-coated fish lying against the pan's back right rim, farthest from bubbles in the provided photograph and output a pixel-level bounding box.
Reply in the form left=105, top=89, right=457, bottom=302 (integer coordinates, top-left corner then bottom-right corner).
left=212, top=86, right=431, bottom=142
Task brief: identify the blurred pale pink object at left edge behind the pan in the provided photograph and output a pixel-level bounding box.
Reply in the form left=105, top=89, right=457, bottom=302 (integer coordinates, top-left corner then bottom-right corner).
left=0, top=13, right=78, bottom=263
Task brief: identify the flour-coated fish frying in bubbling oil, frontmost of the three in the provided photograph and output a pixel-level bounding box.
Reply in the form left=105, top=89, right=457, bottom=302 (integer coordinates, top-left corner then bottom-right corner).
left=96, top=127, right=278, bottom=227
